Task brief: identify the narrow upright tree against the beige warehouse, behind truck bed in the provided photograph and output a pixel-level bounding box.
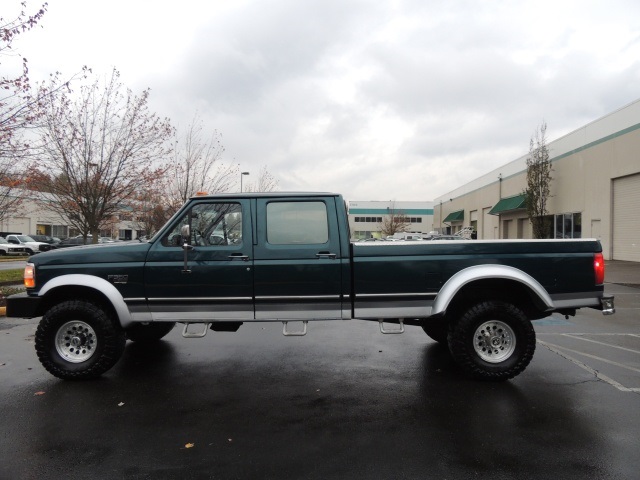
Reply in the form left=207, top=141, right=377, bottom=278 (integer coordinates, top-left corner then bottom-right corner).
left=524, top=122, right=553, bottom=238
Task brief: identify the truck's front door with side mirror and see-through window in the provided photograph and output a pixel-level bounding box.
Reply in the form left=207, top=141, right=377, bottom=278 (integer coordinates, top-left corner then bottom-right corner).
left=145, top=198, right=254, bottom=322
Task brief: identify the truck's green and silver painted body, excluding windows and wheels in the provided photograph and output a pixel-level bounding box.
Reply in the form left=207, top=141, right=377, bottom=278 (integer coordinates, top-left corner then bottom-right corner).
left=7, top=193, right=604, bottom=328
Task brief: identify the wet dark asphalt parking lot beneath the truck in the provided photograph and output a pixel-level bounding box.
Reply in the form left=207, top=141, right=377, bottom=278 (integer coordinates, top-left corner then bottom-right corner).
left=0, top=284, right=640, bottom=480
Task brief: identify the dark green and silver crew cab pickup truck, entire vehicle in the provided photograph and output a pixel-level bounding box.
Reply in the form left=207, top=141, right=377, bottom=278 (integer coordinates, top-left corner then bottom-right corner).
left=7, top=193, right=614, bottom=380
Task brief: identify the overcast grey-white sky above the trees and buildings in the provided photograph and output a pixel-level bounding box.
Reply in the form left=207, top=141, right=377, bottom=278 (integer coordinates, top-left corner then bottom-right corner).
left=12, top=0, right=640, bottom=201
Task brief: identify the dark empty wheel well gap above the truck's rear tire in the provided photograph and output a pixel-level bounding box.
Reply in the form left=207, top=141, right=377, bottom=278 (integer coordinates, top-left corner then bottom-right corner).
left=446, top=278, right=547, bottom=320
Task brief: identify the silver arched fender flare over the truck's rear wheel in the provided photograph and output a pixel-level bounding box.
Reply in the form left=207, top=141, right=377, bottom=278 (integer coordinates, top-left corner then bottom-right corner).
left=431, top=265, right=554, bottom=315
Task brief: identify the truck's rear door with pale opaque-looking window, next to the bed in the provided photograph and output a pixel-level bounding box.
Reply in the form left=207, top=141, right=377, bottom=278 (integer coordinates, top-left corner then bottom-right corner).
left=254, top=197, right=350, bottom=320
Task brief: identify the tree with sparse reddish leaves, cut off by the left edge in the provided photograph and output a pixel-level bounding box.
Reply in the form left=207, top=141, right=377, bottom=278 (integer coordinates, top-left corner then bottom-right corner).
left=0, top=2, right=47, bottom=222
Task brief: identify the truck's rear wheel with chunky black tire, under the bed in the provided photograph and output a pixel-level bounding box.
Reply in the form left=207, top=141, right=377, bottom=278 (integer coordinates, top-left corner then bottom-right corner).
left=449, top=301, right=536, bottom=381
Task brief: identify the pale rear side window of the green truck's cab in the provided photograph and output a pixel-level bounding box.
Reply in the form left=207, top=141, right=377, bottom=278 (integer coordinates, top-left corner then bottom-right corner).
left=267, top=202, right=329, bottom=245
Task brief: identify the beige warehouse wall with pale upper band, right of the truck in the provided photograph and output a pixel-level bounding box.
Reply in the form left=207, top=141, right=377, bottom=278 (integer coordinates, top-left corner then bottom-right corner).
left=433, top=100, right=640, bottom=261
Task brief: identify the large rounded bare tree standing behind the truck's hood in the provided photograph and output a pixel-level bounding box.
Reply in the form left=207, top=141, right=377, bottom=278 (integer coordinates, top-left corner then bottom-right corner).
left=33, top=69, right=173, bottom=243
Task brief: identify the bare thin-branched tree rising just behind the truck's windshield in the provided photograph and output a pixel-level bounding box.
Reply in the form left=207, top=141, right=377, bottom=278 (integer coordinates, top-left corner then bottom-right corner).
left=166, top=115, right=239, bottom=214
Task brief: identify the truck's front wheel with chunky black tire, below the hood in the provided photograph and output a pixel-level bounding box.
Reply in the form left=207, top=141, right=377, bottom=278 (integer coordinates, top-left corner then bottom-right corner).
left=35, top=300, right=126, bottom=380
